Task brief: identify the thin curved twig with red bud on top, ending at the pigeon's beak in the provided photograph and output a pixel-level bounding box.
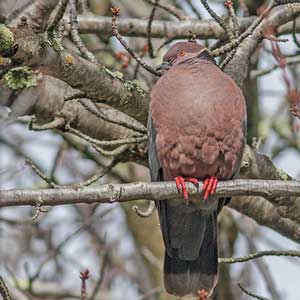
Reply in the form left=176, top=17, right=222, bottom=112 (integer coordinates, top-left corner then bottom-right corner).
left=111, top=7, right=161, bottom=76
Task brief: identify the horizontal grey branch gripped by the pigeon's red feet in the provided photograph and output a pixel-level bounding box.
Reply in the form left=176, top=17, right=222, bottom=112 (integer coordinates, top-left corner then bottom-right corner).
left=0, top=179, right=300, bottom=207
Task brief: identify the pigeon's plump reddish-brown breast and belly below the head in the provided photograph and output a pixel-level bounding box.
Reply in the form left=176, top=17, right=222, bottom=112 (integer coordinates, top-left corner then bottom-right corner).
left=150, top=59, right=246, bottom=180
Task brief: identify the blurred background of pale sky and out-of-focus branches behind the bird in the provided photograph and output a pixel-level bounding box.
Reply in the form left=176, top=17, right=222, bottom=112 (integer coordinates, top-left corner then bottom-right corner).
left=0, top=0, right=300, bottom=300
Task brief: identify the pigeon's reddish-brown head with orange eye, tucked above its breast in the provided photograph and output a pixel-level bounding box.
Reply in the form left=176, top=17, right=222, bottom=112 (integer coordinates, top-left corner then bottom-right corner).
left=157, top=42, right=215, bottom=71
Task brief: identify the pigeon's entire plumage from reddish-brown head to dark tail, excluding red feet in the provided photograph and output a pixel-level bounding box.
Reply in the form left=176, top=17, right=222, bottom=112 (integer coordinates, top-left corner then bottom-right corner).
left=148, top=42, right=246, bottom=296
